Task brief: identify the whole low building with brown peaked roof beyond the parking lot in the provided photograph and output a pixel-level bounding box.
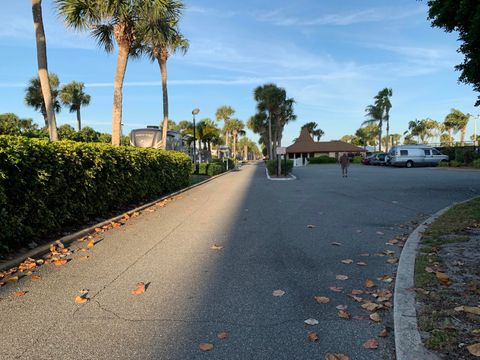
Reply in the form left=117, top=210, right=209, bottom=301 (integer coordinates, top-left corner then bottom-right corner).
left=287, top=128, right=367, bottom=166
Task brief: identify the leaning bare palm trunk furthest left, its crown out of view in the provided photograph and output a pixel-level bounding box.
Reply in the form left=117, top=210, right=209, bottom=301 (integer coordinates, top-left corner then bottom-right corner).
left=32, top=0, right=58, bottom=141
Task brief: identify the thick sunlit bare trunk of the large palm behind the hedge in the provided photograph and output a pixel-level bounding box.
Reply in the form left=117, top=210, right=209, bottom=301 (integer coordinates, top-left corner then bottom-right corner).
left=112, top=43, right=130, bottom=146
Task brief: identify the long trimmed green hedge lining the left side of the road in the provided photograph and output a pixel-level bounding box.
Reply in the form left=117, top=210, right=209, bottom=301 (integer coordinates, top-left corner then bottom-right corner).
left=0, top=136, right=191, bottom=248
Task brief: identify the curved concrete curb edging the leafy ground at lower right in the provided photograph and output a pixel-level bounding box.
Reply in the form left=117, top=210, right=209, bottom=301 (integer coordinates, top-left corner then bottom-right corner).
left=393, top=196, right=478, bottom=360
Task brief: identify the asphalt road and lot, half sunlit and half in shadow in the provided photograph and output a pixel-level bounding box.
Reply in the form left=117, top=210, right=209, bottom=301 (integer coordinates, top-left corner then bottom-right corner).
left=0, top=165, right=480, bottom=360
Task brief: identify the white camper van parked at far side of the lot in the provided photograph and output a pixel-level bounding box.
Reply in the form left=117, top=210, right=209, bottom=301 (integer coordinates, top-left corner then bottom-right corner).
left=387, top=145, right=449, bottom=168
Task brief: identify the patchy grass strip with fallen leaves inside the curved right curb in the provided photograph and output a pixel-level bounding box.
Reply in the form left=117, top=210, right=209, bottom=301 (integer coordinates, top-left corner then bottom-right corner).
left=415, top=198, right=480, bottom=359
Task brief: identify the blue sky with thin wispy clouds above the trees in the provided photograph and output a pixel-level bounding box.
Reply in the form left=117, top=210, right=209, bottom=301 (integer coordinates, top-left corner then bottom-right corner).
left=0, top=0, right=480, bottom=145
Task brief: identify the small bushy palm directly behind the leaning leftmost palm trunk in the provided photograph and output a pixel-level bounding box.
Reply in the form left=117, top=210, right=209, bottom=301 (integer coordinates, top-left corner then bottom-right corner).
left=25, top=73, right=62, bottom=128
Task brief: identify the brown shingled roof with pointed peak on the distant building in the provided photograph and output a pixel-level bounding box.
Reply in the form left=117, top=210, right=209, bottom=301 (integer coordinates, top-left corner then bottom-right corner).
left=287, top=128, right=366, bottom=154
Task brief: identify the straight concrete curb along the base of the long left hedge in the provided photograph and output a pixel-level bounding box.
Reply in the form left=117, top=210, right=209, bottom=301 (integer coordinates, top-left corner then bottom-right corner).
left=0, top=170, right=232, bottom=271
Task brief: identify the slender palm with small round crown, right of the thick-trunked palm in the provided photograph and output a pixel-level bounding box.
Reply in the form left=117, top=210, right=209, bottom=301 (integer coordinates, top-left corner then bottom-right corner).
left=142, top=2, right=189, bottom=149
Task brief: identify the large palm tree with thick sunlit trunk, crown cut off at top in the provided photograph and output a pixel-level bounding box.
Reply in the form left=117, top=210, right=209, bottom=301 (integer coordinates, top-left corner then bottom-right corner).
left=56, top=0, right=179, bottom=145
